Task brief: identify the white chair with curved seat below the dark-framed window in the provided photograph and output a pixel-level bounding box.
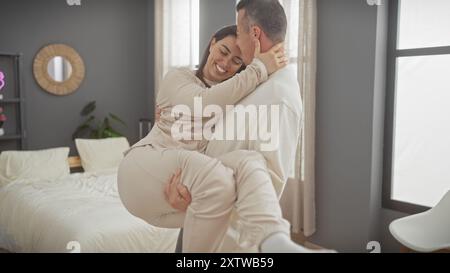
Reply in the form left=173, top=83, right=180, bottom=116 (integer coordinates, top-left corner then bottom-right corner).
left=389, top=191, right=450, bottom=252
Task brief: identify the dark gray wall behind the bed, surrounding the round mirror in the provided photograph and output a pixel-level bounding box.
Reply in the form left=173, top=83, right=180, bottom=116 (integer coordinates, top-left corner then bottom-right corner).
left=0, top=0, right=154, bottom=154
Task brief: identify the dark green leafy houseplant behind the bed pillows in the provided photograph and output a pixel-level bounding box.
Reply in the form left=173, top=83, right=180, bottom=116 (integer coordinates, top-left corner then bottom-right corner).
left=72, top=101, right=127, bottom=139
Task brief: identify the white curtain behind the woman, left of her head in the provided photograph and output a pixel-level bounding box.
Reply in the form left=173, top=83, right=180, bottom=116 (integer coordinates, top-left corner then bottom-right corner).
left=155, top=0, right=200, bottom=96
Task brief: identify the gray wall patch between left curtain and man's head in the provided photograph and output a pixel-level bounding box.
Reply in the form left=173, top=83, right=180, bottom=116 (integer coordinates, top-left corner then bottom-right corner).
left=199, top=0, right=236, bottom=61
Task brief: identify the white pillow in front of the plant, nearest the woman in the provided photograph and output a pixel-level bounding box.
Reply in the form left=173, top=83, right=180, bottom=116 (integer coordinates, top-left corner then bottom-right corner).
left=75, top=137, right=130, bottom=172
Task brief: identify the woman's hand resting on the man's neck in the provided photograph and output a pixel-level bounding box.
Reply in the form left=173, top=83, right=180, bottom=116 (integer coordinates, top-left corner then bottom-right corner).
left=254, top=39, right=289, bottom=75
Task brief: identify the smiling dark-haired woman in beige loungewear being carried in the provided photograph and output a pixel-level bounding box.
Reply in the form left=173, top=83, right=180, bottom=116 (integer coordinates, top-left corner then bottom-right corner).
left=118, top=26, right=298, bottom=252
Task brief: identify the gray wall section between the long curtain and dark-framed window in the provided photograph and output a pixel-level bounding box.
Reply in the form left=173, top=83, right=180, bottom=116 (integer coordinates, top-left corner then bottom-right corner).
left=311, top=0, right=410, bottom=252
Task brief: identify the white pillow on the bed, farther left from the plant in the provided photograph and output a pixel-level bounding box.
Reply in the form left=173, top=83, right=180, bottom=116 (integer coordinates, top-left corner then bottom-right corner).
left=0, top=147, right=70, bottom=186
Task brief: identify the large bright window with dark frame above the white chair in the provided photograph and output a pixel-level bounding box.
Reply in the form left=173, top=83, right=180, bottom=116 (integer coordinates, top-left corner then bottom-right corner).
left=383, top=0, right=450, bottom=213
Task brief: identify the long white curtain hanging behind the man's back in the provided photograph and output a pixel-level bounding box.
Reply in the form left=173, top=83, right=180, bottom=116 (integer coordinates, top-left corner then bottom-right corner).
left=280, top=0, right=317, bottom=237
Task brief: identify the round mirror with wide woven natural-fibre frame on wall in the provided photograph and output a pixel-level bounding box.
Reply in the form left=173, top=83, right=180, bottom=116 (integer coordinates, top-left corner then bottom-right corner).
left=33, top=44, right=85, bottom=96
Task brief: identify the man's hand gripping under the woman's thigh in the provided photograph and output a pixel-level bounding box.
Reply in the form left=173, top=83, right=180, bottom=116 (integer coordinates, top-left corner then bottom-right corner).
left=164, top=170, right=192, bottom=212
